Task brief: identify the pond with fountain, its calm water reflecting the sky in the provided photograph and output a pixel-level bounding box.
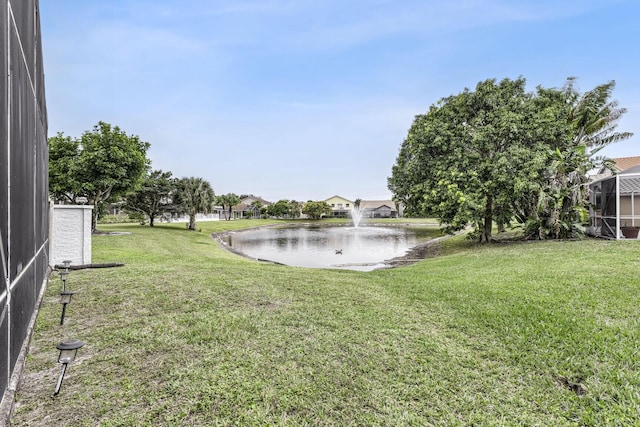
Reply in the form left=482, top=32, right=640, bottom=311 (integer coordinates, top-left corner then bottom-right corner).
left=221, top=224, right=440, bottom=271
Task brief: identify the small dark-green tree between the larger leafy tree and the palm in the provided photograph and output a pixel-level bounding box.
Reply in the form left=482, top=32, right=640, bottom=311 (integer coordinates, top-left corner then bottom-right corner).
left=124, top=170, right=176, bottom=227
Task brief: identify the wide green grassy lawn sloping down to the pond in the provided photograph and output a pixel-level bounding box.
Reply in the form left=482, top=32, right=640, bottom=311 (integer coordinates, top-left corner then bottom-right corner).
left=12, top=220, right=640, bottom=426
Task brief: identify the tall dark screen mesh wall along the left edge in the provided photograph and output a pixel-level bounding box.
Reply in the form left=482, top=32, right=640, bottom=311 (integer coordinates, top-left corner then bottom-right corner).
left=0, top=0, right=49, bottom=406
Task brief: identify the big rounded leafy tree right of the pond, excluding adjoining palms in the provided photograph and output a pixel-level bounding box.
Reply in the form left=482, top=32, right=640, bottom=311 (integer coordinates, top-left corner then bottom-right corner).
left=389, top=78, right=544, bottom=242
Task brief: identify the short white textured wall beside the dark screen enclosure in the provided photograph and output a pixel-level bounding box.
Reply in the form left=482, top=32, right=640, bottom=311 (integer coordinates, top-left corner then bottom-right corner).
left=49, top=205, right=93, bottom=266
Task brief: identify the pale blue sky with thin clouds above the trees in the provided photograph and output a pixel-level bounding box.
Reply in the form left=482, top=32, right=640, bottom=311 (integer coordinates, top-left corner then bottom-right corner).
left=40, top=0, right=640, bottom=201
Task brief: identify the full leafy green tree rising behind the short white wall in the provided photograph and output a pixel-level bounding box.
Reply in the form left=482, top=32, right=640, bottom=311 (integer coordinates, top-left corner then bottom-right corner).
left=49, top=121, right=150, bottom=232
